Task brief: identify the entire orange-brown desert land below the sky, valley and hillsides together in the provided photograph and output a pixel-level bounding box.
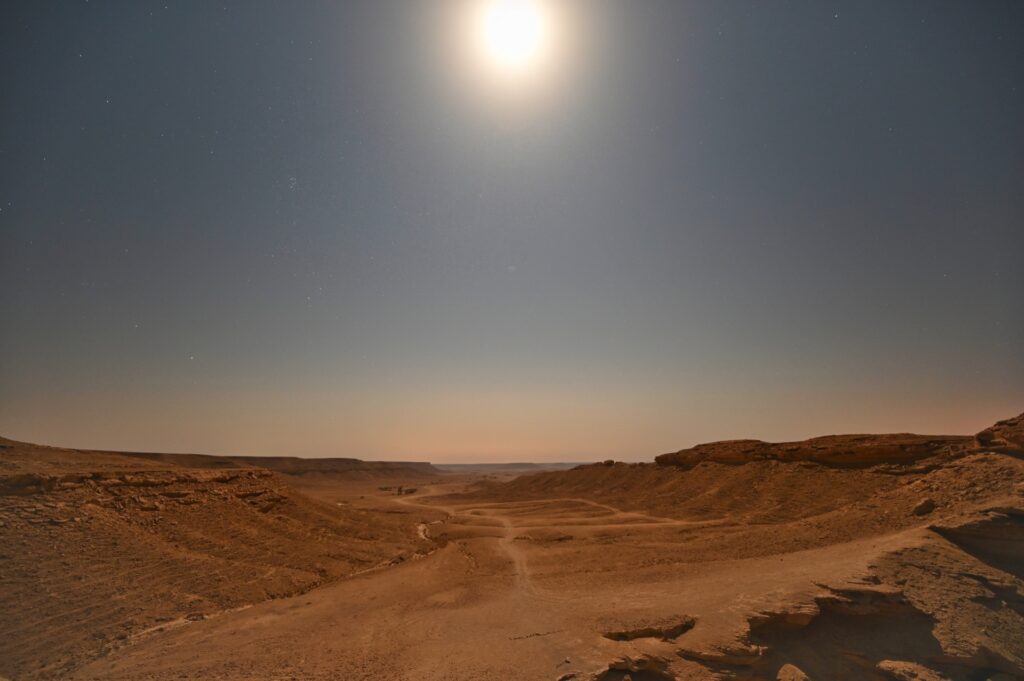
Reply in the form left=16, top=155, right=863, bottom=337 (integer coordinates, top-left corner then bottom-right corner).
left=0, top=417, right=1024, bottom=681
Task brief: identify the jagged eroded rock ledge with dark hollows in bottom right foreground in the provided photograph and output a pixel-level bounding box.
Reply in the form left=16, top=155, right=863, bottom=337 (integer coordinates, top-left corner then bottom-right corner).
left=678, top=574, right=1022, bottom=681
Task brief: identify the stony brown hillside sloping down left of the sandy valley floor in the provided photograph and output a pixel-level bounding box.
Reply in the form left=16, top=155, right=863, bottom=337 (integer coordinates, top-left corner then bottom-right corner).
left=0, top=440, right=425, bottom=679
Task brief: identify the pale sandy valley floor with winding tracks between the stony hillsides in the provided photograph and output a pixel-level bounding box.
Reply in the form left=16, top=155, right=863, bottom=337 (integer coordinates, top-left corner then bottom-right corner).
left=64, top=477, right=966, bottom=681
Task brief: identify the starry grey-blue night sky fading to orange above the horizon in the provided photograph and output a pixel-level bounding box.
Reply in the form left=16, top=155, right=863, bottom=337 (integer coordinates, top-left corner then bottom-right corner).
left=0, top=0, right=1024, bottom=461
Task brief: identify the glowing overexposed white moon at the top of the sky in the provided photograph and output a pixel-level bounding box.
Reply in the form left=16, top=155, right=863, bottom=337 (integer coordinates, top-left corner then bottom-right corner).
left=478, top=0, right=549, bottom=72
